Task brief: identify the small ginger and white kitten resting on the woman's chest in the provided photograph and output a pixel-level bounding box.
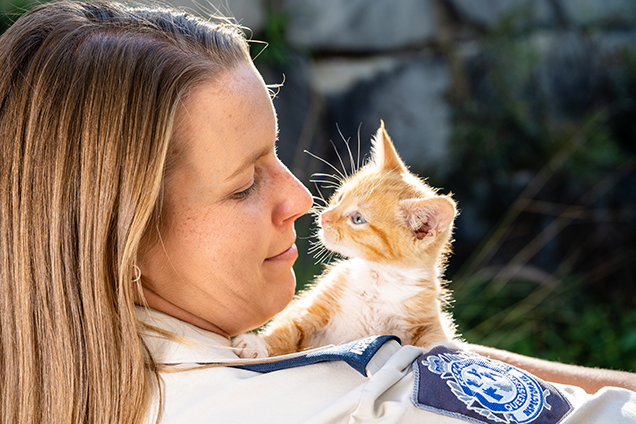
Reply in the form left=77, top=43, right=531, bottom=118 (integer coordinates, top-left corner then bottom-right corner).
left=233, top=122, right=456, bottom=358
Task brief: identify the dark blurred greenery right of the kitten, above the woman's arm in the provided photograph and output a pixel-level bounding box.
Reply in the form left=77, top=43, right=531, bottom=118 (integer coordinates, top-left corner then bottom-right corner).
left=445, top=10, right=636, bottom=371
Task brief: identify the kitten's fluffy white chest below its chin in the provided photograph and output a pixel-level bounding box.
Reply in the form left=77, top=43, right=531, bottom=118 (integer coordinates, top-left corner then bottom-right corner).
left=312, top=259, right=426, bottom=346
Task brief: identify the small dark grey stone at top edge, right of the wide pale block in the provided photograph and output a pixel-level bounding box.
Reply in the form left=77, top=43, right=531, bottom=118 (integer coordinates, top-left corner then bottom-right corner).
left=448, top=0, right=555, bottom=26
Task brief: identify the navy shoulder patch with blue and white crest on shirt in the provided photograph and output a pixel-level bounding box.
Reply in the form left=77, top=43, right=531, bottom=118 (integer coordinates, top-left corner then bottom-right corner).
left=413, top=346, right=572, bottom=424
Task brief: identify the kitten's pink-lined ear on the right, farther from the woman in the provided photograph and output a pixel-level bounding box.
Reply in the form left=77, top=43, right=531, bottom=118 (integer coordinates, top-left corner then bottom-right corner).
left=400, top=196, right=456, bottom=240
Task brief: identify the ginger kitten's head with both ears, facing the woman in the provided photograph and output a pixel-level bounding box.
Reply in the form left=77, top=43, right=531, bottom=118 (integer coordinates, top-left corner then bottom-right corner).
left=319, top=122, right=456, bottom=266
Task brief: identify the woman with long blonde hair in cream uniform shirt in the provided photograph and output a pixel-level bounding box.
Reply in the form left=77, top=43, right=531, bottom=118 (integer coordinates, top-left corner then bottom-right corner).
left=0, top=2, right=636, bottom=423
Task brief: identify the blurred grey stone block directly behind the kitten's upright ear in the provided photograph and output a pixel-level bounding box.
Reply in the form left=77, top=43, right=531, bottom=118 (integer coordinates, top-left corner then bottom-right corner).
left=327, top=57, right=450, bottom=174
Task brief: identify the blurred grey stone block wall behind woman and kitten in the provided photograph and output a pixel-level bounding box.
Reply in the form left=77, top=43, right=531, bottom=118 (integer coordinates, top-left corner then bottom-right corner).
left=173, top=0, right=636, bottom=177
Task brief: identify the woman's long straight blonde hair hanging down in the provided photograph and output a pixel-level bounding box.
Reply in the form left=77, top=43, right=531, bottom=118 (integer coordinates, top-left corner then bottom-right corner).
left=0, top=2, right=250, bottom=423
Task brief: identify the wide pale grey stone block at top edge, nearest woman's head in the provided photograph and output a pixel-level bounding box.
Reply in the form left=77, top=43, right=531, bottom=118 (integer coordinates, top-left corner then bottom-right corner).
left=285, top=0, right=436, bottom=51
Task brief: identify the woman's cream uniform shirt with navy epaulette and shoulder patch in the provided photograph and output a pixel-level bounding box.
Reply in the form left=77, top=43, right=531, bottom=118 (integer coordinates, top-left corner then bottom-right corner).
left=137, top=308, right=636, bottom=424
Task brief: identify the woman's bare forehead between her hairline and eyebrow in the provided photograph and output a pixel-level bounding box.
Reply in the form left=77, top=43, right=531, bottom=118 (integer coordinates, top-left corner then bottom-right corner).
left=171, top=65, right=278, bottom=188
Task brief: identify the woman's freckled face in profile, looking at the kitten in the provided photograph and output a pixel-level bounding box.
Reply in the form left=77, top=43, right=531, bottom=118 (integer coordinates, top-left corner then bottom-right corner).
left=139, top=64, right=311, bottom=336
